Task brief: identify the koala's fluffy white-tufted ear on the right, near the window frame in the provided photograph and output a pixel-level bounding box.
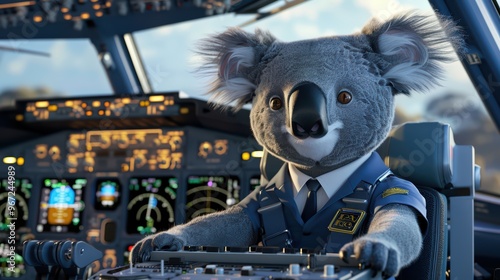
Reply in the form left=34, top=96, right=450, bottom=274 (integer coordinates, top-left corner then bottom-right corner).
left=362, top=12, right=464, bottom=94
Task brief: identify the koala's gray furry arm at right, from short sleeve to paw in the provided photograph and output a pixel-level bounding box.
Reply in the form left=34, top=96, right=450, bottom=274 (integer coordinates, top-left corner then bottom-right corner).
left=340, top=204, right=423, bottom=277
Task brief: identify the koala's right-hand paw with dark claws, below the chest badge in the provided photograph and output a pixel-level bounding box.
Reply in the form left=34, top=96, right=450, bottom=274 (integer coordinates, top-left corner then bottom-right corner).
left=339, top=237, right=400, bottom=278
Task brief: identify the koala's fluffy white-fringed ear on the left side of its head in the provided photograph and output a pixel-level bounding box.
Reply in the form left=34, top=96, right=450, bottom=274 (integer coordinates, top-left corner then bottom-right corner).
left=199, top=28, right=276, bottom=110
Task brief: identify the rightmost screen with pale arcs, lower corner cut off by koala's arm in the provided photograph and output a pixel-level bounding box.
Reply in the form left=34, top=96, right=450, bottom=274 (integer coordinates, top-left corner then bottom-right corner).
left=186, top=176, right=241, bottom=221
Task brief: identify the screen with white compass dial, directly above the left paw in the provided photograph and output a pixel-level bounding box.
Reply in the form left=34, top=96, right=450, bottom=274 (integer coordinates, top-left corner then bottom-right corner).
left=127, top=177, right=178, bottom=235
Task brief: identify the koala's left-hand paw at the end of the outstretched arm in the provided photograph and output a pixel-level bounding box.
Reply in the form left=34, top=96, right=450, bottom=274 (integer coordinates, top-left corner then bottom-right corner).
left=130, top=232, right=186, bottom=263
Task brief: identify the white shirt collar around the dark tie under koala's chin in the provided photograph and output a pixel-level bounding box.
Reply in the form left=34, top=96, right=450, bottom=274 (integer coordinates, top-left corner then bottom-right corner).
left=288, top=154, right=371, bottom=198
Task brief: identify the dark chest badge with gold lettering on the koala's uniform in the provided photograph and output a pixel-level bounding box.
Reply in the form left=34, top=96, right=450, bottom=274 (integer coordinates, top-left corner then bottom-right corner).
left=328, top=208, right=366, bottom=234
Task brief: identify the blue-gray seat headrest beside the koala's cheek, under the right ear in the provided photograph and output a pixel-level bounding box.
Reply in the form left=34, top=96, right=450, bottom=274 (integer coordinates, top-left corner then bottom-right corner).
left=377, top=122, right=455, bottom=189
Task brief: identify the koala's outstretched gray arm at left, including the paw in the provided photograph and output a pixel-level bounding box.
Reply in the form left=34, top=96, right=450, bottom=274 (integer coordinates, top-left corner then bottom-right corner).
left=130, top=206, right=257, bottom=263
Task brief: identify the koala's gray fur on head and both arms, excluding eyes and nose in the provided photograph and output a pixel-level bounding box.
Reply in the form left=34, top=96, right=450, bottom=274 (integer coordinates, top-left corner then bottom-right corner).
left=132, top=10, right=463, bottom=276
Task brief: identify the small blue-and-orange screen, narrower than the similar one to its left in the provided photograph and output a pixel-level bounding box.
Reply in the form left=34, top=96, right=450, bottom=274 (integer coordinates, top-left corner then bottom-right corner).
left=94, top=179, right=121, bottom=210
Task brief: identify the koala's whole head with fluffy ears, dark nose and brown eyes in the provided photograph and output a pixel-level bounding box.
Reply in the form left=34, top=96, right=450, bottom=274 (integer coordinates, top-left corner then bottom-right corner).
left=200, top=13, right=462, bottom=175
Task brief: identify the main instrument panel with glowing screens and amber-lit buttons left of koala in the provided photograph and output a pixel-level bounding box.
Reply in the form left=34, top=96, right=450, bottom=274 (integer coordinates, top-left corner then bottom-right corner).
left=0, top=93, right=261, bottom=279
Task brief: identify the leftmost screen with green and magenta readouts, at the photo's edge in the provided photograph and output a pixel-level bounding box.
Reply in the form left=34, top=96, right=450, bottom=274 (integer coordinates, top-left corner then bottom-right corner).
left=0, top=178, right=33, bottom=232
